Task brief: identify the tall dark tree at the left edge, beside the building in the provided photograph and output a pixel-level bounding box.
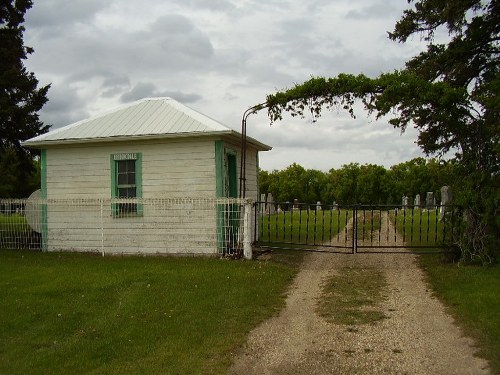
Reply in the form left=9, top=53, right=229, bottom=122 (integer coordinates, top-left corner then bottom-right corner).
left=0, top=0, right=50, bottom=197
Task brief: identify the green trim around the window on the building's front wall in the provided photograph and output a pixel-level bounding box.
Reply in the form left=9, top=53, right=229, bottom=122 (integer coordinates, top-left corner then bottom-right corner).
left=110, top=152, right=144, bottom=218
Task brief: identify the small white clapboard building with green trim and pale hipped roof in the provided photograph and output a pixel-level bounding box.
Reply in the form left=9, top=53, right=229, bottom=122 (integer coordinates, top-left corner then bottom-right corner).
left=23, top=98, right=271, bottom=254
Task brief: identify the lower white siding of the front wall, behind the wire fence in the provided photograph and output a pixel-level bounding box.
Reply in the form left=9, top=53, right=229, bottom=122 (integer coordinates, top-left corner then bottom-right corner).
left=47, top=201, right=217, bottom=255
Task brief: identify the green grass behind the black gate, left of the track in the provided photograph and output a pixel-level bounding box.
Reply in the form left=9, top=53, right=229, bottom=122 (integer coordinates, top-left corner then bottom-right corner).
left=259, top=210, right=352, bottom=245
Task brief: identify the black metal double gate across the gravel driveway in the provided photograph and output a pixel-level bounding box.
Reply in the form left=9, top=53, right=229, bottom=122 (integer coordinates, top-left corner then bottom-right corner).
left=254, top=202, right=461, bottom=254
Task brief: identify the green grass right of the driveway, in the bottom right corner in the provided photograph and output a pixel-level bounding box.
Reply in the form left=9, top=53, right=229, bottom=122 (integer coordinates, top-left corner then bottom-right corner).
left=419, top=255, right=500, bottom=374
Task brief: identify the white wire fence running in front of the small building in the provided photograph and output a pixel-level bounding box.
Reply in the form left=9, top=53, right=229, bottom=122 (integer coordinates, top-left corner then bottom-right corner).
left=0, top=198, right=253, bottom=257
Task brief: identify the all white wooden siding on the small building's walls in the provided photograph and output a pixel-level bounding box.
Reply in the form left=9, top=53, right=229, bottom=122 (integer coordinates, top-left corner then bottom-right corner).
left=46, top=137, right=258, bottom=254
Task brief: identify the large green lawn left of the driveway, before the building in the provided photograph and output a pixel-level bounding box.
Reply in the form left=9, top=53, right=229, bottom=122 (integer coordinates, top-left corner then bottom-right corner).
left=0, top=250, right=301, bottom=374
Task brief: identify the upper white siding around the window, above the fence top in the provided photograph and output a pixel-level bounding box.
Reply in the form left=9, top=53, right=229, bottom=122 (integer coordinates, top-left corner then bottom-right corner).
left=47, top=139, right=215, bottom=199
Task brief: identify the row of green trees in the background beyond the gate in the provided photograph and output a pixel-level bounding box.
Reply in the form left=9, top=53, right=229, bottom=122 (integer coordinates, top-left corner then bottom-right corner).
left=259, top=158, right=460, bottom=204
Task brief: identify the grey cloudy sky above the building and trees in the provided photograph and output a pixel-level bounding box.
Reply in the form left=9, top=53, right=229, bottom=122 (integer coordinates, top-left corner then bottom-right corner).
left=25, top=0, right=430, bottom=170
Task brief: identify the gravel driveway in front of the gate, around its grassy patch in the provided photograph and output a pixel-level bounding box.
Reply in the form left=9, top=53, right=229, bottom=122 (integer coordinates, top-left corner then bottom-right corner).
left=230, top=214, right=490, bottom=375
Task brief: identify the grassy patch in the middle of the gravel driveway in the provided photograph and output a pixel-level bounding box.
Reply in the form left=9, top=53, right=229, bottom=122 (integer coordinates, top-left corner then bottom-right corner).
left=317, top=268, right=387, bottom=326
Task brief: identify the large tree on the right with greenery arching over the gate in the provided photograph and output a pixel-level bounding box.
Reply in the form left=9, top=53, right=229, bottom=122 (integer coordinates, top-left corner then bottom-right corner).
left=266, top=0, right=500, bottom=262
